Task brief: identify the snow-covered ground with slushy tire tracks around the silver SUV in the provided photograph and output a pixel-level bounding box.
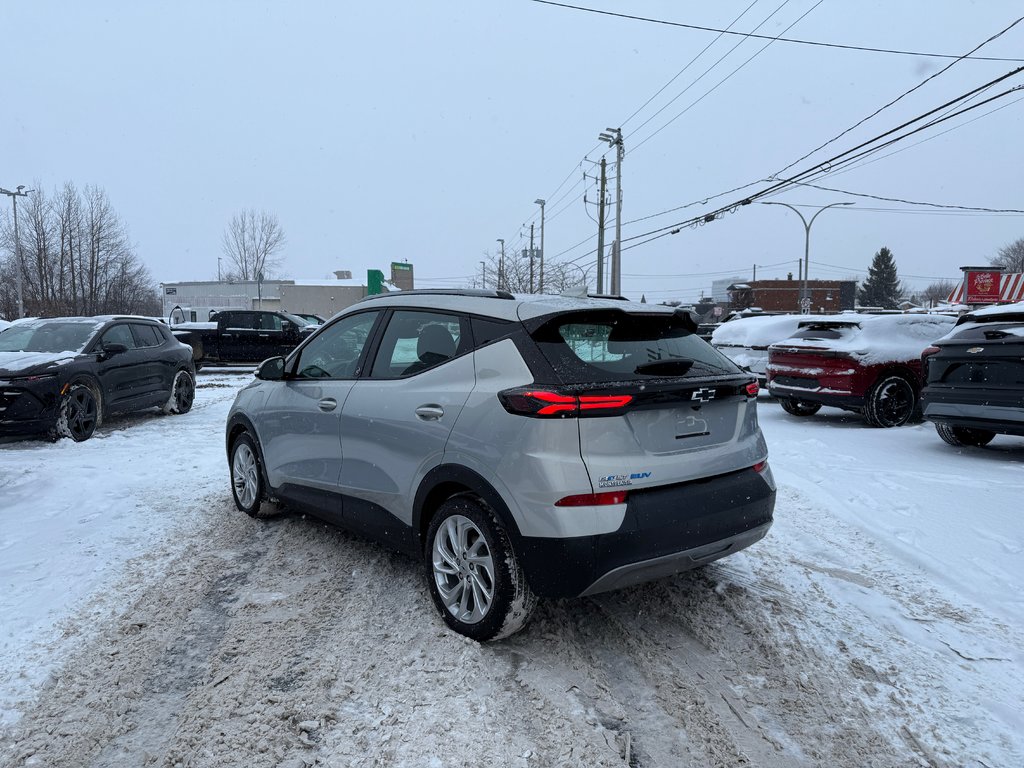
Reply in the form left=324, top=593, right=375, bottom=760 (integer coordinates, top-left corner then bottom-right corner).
left=0, top=371, right=1024, bottom=768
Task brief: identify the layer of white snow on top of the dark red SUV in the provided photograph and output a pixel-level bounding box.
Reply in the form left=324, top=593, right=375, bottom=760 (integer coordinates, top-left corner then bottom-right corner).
left=780, top=314, right=955, bottom=366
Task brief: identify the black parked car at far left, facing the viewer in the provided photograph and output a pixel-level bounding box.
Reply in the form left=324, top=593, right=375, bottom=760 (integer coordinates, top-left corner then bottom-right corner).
left=0, top=315, right=196, bottom=441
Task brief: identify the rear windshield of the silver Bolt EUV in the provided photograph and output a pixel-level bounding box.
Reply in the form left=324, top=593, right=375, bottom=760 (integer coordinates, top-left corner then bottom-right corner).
left=532, top=312, right=739, bottom=384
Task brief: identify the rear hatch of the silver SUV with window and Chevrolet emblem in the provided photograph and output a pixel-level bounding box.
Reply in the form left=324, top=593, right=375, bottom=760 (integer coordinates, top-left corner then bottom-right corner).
left=526, top=309, right=766, bottom=493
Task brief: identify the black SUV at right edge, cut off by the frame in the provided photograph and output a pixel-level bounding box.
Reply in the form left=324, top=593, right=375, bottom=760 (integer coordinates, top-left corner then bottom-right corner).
left=921, top=302, right=1024, bottom=445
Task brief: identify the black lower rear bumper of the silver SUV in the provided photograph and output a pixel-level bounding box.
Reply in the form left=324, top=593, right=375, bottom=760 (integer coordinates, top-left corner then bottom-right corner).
left=517, top=462, right=775, bottom=597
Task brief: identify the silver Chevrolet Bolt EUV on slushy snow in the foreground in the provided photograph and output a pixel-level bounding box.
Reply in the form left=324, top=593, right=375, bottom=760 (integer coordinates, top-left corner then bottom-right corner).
left=226, top=290, right=775, bottom=641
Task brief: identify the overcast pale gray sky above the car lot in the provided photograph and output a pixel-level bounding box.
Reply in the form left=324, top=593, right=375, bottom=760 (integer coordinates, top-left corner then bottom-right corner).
left=0, top=0, right=1024, bottom=301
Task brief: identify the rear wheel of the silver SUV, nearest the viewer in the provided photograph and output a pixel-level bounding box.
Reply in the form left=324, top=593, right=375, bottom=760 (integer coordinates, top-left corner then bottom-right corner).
left=424, top=496, right=537, bottom=642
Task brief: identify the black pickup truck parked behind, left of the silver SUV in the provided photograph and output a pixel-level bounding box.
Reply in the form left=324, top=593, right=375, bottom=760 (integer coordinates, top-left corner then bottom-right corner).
left=171, top=309, right=315, bottom=368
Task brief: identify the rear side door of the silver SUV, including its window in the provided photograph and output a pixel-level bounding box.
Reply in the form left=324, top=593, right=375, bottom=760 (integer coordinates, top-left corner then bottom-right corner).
left=341, top=309, right=476, bottom=536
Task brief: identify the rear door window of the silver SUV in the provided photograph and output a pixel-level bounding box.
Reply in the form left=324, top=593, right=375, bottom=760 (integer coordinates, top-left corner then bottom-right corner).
left=370, top=310, right=469, bottom=379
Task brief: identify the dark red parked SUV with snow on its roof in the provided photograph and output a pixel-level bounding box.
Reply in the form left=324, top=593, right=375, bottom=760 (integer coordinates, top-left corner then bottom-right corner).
left=767, top=314, right=955, bottom=427
